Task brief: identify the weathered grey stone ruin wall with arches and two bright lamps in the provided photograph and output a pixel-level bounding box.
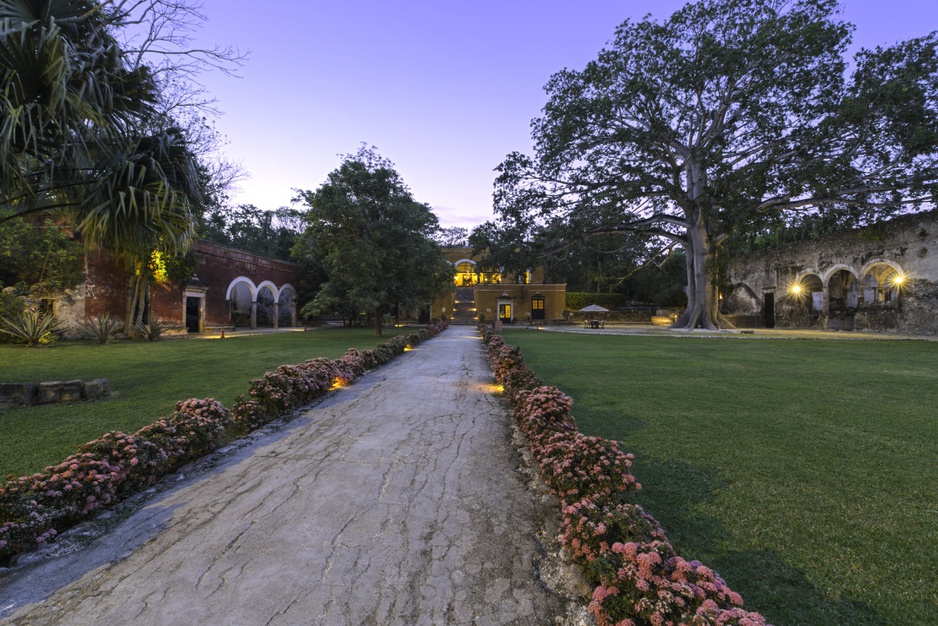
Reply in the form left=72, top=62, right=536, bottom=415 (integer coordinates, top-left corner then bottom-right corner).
left=723, top=211, right=938, bottom=334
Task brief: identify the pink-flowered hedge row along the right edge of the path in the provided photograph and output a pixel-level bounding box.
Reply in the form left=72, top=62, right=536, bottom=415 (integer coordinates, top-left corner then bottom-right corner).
left=480, top=327, right=766, bottom=626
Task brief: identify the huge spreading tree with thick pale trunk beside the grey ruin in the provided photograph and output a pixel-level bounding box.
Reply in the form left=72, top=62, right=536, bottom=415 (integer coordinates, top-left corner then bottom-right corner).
left=495, top=0, right=938, bottom=329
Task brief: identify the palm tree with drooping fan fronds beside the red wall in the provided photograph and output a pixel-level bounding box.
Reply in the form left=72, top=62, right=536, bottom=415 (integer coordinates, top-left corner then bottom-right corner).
left=0, top=0, right=200, bottom=327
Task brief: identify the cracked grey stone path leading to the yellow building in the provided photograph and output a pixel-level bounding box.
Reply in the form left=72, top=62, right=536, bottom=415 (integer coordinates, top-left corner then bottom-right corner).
left=0, top=326, right=564, bottom=626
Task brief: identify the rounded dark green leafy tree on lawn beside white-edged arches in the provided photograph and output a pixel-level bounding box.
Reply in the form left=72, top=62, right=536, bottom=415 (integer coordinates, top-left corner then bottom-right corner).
left=296, top=147, right=452, bottom=336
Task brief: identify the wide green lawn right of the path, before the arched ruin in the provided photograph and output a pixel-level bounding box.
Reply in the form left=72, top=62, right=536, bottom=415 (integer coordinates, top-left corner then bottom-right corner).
left=506, top=330, right=938, bottom=626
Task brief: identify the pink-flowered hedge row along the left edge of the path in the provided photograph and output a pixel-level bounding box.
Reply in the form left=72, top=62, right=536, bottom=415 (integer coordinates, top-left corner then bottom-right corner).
left=0, top=322, right=446, bottom=564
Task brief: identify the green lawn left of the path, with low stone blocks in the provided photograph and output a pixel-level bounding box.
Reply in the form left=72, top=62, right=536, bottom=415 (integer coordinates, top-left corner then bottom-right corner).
left=0, top=329, right=404, bottom=477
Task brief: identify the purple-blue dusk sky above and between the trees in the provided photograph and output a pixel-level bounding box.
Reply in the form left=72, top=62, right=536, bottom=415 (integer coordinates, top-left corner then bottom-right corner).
left=190, top=0, right=938, bottom=227
